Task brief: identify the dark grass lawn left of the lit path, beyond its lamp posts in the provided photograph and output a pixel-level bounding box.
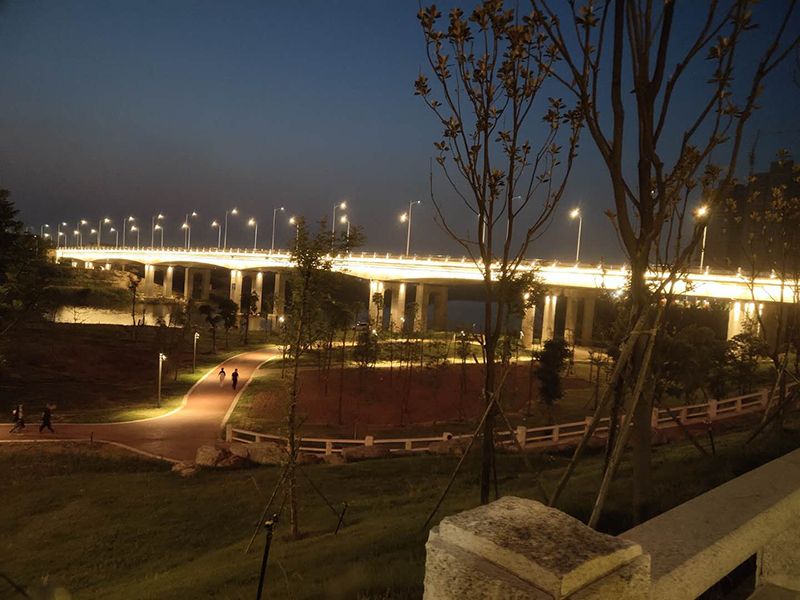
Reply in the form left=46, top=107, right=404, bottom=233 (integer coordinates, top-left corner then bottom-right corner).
left=0, top=323, right=272, bottom=423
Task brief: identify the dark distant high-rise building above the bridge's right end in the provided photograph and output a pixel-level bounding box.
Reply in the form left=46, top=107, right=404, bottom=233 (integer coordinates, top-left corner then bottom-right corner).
left=695, top=160, right=800, bottom=273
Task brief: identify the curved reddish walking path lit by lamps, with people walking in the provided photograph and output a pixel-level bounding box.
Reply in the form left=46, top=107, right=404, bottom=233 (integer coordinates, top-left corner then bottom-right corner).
left=0, top=348, right=278, bottom=461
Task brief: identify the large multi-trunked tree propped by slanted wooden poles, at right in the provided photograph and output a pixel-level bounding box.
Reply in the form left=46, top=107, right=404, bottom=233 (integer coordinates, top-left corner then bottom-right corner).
left=532, top=0, right=798, bottom=525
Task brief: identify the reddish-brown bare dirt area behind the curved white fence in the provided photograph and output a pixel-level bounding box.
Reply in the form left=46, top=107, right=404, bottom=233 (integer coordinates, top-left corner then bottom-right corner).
left=247, top=364, right=593, bottom=427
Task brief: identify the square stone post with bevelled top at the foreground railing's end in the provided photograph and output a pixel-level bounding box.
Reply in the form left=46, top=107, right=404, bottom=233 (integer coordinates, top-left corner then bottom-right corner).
left=423, top=496, right=650, bottom=600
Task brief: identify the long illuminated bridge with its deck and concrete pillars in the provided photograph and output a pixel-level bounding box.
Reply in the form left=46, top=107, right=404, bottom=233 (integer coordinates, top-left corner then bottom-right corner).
left=55, top=246, right=798, bottom=346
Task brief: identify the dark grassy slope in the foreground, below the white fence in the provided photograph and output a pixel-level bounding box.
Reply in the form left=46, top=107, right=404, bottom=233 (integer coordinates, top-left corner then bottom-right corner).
left=0, top=418, right=800, bottom=600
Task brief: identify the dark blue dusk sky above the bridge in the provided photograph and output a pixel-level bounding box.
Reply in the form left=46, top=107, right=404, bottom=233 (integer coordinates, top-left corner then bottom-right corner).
left=0, top=0, right=800, bottom=260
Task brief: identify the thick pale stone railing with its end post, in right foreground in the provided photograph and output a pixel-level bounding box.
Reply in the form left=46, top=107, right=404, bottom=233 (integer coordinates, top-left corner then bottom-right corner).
left=424, top=450, right=800, bottom=600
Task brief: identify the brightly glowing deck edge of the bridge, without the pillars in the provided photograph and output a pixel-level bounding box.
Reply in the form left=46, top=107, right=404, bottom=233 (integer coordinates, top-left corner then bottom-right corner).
left=55, top=247, right=800, bottom=303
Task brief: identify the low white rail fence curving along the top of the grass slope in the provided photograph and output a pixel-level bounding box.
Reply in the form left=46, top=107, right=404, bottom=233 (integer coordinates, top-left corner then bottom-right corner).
left=225, top=384, right=797, bottom=454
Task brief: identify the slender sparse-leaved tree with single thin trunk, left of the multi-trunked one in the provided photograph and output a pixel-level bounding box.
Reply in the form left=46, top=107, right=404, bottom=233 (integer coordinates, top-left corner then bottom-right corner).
left=415, top=0, right=581, bottom=503
